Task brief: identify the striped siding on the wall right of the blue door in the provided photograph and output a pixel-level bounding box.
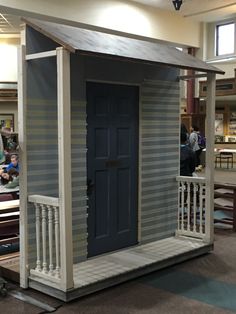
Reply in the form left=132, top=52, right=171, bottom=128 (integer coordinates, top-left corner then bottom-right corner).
left=140, top=81, right=179, bottom=243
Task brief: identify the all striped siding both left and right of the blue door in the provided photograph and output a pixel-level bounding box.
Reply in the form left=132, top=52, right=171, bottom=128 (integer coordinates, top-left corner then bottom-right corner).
left=27, top=81, right=179, bottom=263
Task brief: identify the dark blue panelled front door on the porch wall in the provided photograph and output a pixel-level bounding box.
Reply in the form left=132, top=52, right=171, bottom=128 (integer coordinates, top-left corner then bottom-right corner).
left=87, top=83, right=139, bottom=256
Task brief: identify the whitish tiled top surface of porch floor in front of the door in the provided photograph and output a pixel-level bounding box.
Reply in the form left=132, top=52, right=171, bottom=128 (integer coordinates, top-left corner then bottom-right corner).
left=74, top=237, right=208, bottom=289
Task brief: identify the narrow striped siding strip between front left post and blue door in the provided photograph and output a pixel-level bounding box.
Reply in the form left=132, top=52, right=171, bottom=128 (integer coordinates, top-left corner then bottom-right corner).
left=71, top=101, right=87, bottom=263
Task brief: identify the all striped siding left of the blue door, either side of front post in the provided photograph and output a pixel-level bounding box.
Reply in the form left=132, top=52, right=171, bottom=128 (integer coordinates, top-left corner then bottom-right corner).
left=27, top=99, right=87, bottom=265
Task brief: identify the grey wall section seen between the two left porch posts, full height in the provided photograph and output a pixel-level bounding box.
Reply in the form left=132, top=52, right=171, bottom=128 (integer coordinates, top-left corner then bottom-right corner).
left=26, top=54, right=58, bottom=267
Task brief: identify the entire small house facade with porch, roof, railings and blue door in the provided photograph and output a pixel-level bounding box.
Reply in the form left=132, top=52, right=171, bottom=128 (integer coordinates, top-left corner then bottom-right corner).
left=19, top=20, right=221, bottom=300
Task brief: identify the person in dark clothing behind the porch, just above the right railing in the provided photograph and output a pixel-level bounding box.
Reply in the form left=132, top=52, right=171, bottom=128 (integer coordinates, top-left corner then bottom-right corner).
left=180, top=132, right=196, bottom=177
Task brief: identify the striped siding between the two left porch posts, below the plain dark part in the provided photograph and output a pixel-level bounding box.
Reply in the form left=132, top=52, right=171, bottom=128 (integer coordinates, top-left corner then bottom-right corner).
left=26, top=99, right=58, bottom=267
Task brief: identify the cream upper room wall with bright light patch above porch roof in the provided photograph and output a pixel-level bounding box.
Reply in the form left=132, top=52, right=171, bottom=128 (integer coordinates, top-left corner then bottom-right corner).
left=0, top=0, right=203, bottom=47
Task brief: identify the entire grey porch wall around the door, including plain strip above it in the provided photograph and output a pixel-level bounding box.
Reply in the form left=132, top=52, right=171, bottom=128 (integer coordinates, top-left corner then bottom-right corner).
left=27, top=35, right=179, bottom=265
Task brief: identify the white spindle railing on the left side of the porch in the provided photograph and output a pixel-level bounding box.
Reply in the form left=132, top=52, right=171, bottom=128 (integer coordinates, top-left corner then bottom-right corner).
left=28, top=195, right=61, bottom=282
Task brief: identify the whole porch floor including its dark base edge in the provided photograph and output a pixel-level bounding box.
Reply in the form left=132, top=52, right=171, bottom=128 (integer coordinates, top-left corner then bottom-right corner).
left=30, top=237, right=213, bottom=301
